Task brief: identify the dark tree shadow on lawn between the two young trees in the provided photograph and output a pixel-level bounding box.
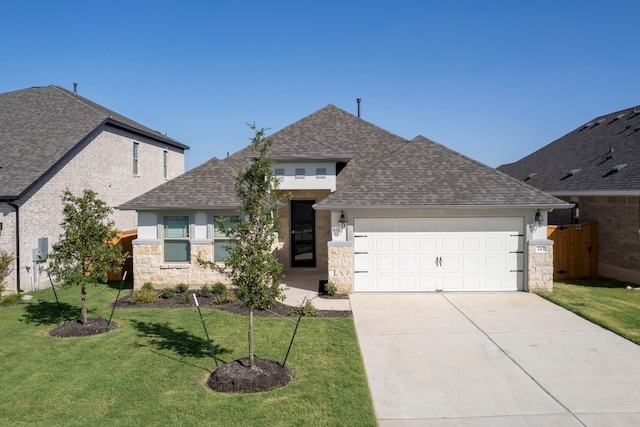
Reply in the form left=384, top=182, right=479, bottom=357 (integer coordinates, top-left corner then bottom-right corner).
left=131, top=320, right=230, bottom=363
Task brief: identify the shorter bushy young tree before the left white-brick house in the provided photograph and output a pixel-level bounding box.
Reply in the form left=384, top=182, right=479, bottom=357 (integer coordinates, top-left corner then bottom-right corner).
left=47, top=189, right=127, bottom=324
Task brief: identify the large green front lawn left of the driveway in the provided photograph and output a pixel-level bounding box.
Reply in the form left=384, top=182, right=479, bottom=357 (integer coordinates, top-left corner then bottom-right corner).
left=0, top=285, right=376, bottom=426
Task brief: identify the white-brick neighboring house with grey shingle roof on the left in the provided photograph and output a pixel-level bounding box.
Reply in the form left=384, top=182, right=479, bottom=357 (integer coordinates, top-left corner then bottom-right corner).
left=0, top=86, right=188, bottom=291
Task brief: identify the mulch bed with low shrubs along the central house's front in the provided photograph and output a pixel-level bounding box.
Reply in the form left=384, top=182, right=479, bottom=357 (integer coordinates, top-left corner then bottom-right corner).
left=110, top=291, right=352, bottom=317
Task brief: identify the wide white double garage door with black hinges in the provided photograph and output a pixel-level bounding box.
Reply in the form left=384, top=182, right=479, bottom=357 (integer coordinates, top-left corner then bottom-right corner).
left=353, top=218, right=524, bottom=292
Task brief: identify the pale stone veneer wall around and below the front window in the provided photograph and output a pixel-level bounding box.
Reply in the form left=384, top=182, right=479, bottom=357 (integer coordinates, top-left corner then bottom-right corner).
left=133, top=241, right=229, bottom=289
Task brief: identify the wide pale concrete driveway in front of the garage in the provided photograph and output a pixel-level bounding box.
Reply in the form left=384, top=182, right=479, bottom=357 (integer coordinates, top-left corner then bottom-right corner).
left=351, top=292, right=640, bottom=427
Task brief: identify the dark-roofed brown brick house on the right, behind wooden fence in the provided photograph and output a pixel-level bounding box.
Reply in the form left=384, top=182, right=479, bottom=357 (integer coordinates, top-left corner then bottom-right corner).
left=498, top=107, right=640, bottom=283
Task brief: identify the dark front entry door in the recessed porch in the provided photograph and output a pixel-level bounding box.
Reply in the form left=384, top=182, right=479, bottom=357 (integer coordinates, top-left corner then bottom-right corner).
left=291, top=200, right=316, bottom=267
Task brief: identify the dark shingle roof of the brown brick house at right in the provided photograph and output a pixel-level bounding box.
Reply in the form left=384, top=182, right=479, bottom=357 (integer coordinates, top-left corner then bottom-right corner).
left=498, top=107, right=640, bottom=195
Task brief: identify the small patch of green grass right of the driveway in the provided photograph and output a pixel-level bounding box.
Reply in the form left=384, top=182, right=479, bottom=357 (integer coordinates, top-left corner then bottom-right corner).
left=540, top=277, right=640, bottom=344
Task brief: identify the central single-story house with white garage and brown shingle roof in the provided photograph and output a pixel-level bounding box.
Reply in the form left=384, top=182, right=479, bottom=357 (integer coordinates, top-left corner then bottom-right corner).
left=120, top=105, right=569, bottom=292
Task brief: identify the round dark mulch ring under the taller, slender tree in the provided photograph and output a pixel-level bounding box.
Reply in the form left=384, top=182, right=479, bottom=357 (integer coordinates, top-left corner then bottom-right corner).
left=207, top=357, right=293, bottom=393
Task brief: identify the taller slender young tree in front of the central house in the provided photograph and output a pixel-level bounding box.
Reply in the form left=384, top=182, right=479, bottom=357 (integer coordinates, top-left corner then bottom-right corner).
left=200, top=124, right=284, bottom=368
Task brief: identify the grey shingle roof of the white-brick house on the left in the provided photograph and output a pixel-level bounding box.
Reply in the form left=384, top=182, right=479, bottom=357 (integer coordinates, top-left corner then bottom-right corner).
left=0, top=86, right=189, bottom=200
